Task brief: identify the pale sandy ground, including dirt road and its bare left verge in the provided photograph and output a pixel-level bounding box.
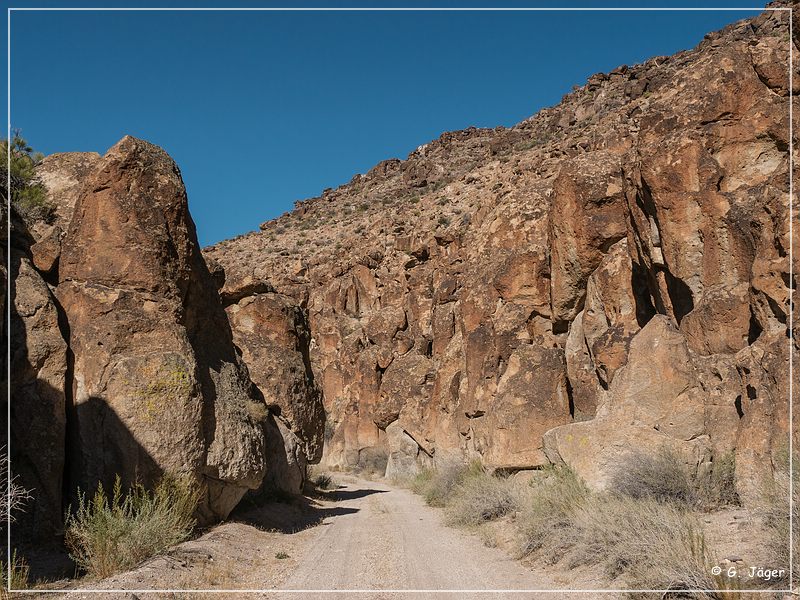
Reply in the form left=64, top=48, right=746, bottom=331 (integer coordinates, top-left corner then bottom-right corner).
left=24, top=477, right=615, bottom=600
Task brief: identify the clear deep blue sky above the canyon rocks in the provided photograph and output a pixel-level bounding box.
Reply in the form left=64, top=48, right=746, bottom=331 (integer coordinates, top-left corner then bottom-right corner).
left=11, top=0, right=758, bottom=245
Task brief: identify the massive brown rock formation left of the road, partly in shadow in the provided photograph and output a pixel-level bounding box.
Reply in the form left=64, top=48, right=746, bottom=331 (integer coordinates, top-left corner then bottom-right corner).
left=10, top=141, right=324, bottom=543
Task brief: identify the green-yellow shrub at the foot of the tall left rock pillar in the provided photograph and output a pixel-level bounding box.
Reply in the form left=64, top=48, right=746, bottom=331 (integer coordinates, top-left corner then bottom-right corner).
left=64, top=476, right=199, bottom=577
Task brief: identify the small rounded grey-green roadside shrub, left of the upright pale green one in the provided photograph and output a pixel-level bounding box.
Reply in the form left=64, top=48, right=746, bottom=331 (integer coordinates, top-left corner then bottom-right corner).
left=447, top=472, right=519, bottom=525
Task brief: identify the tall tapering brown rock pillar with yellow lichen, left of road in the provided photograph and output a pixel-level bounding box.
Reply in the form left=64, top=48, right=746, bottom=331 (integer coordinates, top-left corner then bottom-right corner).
left=56, top=136, right=267, bottom=521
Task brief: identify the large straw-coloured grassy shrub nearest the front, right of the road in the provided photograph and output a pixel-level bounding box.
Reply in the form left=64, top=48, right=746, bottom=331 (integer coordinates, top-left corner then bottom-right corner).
left=575, top=494, right=724, bottom=598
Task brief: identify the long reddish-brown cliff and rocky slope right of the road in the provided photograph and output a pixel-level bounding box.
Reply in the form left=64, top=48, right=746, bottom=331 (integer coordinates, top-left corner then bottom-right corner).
left=204, top=3, right=800, bottom=492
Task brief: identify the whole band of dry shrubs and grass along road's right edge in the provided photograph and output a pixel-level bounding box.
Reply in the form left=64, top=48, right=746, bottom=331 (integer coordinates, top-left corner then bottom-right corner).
left=411, top=451, right=748, bottom=600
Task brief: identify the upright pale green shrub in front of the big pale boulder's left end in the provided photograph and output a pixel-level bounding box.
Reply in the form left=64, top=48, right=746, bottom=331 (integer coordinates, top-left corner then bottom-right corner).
left=516, top=467, right=589, bottom=563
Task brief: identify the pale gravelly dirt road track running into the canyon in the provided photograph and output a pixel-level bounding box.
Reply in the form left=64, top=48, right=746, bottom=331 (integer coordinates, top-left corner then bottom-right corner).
left=279, top=480, right=572, bottom=600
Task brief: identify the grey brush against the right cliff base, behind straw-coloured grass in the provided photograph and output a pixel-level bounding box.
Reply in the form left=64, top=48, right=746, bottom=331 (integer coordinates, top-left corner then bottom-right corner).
left=609, top=447, right=739, bottom=510
